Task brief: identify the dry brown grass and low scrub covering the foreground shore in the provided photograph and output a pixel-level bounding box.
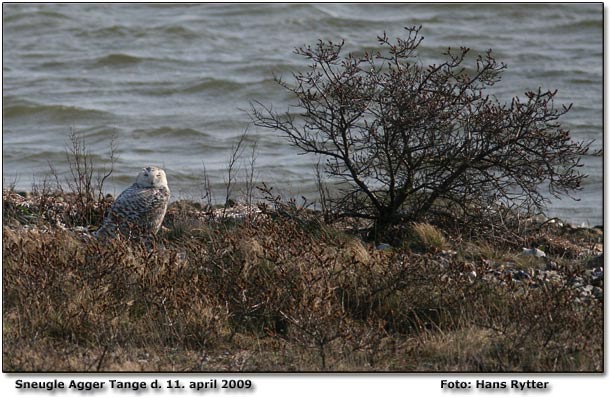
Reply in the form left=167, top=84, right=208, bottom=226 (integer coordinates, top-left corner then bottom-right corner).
left=2, top=192, right=603, bottom=372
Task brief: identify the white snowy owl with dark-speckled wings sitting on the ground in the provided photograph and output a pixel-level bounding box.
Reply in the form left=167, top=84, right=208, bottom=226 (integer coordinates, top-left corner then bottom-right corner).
left=95, top=167, right=170, bottom=238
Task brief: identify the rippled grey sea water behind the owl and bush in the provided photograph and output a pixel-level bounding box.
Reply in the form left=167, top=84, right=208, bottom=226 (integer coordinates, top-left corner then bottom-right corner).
left=2, top=3, right=603, bottom=225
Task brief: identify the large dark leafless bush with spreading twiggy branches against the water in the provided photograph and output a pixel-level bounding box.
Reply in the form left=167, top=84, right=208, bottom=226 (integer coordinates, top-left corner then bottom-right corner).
left=251, top=27, right=589, bottom=240
